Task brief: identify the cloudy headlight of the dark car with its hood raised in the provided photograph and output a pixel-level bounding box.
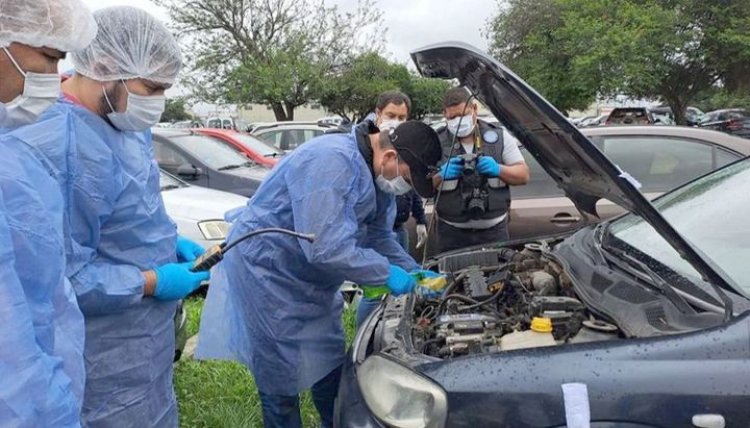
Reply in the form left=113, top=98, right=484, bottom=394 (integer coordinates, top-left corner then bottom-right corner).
left=357, top=355, right=448, bottom=428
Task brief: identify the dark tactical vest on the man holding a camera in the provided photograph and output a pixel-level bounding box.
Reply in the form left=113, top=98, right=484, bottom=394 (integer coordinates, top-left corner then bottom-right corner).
left=436, top=120, right=510, bottom=223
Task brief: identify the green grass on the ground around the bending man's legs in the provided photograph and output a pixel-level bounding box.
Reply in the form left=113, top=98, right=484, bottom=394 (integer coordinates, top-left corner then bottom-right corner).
left=174, top=299, right=355, bottom=428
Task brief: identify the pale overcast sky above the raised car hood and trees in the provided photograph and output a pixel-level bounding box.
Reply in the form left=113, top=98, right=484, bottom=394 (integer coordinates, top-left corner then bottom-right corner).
left=72, top=0, right=497, bottom=68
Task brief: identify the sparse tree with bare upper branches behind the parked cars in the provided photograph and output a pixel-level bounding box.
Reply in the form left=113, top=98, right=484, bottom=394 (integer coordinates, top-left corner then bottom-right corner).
left=153, top=0, right=385, bottom=120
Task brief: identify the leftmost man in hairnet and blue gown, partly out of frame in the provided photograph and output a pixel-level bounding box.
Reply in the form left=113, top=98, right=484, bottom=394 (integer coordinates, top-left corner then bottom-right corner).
left=0, top=0, right=97, bottom=427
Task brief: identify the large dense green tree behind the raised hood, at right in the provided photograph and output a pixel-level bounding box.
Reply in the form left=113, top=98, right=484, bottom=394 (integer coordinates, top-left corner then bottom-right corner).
left=488, top=0, right=750, bottom=123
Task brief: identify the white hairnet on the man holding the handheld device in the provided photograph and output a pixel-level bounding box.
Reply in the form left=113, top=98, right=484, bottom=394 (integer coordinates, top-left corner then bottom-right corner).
left=72, top=6, right=182, bottom=84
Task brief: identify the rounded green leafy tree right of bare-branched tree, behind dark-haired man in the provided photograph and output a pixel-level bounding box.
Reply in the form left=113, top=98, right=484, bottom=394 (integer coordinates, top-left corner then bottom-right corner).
left=320, top=52, right=412, bottom=122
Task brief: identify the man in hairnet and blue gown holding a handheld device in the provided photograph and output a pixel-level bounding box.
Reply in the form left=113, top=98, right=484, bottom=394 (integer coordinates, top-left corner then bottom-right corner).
left=13, top=7, right=208, bottom=427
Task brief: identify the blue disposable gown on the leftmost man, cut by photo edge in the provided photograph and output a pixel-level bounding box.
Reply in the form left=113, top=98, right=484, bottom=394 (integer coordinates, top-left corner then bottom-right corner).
left=0, top=137, right=84, bottom=427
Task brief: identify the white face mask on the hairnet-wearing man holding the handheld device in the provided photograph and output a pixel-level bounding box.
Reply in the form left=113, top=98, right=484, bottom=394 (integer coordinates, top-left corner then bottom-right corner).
left=102, top=81, right=167, bottom=132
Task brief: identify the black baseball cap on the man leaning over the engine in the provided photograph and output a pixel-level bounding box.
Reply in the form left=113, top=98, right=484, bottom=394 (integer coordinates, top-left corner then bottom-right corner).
left=389, top=120, right=443, bottom=198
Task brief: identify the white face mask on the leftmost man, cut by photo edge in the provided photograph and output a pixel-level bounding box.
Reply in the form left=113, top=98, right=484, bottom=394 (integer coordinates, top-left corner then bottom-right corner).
left=0, top=48, right=60, bottom=128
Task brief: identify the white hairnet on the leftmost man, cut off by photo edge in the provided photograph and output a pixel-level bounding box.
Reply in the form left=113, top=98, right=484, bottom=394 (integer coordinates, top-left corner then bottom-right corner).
left=0, top=0, right=96, bottom=52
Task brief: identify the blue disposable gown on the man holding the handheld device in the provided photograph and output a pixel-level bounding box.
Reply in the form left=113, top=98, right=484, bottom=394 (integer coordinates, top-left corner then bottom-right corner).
left=14, top=100, right=177, bottom=427
